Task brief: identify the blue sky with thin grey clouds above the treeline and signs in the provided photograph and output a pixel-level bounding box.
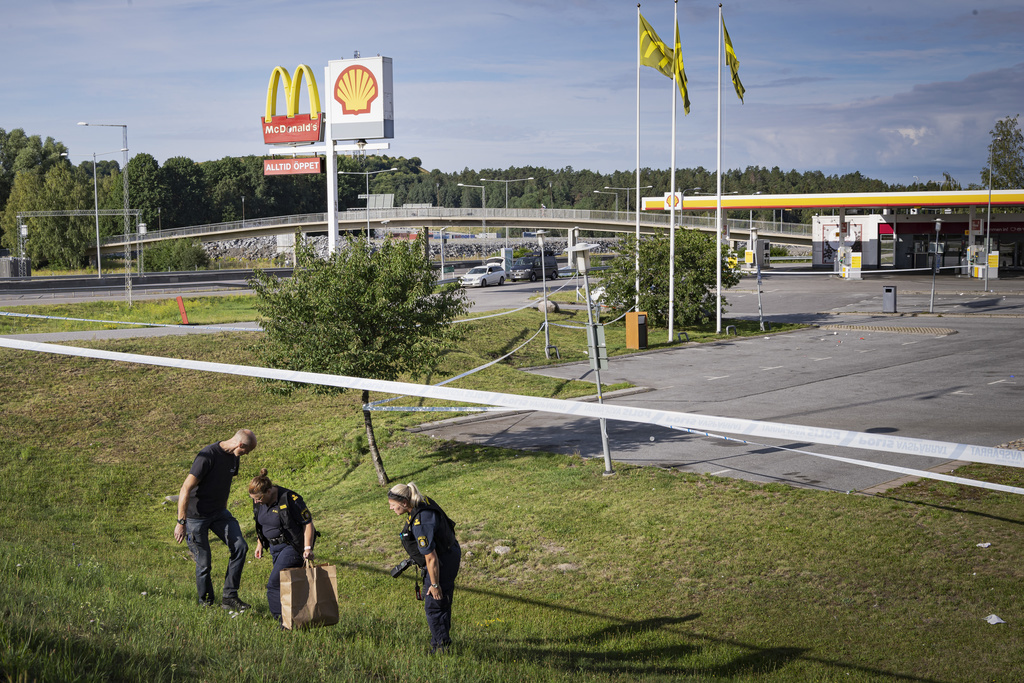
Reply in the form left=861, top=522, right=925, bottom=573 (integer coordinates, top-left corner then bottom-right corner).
left=0, top=0, right=1024, bottom=185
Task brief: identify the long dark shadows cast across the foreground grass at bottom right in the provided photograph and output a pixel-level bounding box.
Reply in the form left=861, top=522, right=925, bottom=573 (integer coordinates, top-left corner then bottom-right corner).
left=339, top=562, right=938, bottom=683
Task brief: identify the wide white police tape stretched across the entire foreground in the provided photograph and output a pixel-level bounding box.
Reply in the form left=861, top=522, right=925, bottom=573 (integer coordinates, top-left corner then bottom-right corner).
left=0, top=337, right=1024, bottom=494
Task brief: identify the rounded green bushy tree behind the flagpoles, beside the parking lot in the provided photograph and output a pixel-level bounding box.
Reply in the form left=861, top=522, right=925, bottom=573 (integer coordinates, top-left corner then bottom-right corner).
left=601, top=229, right=739, bottom=327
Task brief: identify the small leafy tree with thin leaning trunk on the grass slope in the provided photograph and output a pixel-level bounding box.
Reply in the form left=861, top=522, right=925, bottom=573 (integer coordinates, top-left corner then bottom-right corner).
left=252, top=237, right=468, bottom=485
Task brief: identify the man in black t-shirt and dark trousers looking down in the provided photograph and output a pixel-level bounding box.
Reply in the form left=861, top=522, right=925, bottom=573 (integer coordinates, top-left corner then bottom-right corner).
left=174, top=429, right=256, bottom=611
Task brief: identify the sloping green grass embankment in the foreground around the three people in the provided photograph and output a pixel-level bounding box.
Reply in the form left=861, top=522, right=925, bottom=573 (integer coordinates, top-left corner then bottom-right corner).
left=0, top=301, right=1024, bottom=682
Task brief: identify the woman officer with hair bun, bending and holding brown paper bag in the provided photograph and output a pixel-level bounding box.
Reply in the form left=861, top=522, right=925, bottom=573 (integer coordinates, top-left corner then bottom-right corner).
left=249, top=469, right=317, bottom=621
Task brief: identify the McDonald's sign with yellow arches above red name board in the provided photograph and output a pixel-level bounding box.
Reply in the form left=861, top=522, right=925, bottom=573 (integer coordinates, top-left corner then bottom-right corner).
left=260, top=65, right=324, bottom=144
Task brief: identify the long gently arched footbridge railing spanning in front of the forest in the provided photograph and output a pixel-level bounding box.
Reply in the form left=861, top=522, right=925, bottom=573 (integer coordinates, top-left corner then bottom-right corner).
left=101, top=207, right=811, bottom=246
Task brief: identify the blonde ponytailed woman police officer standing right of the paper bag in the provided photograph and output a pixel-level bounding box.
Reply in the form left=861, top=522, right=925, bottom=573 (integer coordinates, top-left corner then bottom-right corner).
left=387, top=481, right=462, bottom=654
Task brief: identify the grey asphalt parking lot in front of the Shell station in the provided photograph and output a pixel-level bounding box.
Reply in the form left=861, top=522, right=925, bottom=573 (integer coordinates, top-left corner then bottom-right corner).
left=411, top=273, right=1024, bottom=492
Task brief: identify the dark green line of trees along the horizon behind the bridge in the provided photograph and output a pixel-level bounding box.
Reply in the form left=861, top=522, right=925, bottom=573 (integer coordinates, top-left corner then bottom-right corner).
left=0, top=116, right=1024, bottom=268
